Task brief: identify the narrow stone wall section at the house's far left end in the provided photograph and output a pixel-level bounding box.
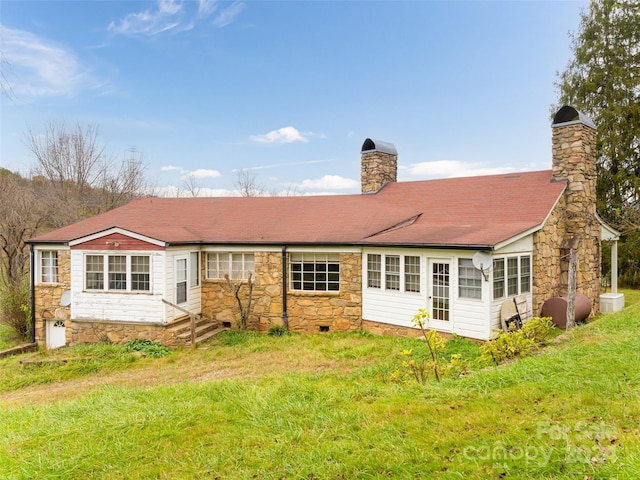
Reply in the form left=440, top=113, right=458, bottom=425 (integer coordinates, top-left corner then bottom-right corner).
left=33, top=250, right=71, bottom=346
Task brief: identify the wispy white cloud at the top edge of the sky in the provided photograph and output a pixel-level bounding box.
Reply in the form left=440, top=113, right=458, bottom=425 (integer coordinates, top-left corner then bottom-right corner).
left=108, top=0, right=244, bottom=37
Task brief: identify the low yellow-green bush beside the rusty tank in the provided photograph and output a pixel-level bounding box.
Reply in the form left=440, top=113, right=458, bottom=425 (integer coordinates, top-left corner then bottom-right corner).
left=480, top=317, right=553, bottom=365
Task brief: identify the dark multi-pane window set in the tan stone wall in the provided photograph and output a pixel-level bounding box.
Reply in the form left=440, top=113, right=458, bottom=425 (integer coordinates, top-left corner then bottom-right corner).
left=289, top=253, right=340, bottom=292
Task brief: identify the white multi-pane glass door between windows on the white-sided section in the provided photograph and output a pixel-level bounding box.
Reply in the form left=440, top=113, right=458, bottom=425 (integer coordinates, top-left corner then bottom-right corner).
left=427, top=259, right=453, bottom=332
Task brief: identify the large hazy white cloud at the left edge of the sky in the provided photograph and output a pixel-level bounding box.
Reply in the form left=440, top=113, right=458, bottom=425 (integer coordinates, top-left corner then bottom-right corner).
left=0, top=25, right=95, bottom=101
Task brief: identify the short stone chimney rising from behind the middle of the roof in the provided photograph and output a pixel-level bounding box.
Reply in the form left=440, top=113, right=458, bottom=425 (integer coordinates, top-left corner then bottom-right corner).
left=360, top=138, right=398, bottom=193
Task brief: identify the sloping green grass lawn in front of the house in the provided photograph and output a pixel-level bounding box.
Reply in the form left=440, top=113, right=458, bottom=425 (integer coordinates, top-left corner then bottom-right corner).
left=0, top=291, right=640, bottom=479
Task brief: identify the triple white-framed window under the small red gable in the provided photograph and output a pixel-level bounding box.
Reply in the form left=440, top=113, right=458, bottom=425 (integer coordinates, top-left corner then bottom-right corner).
left=84, top=255, right=151, bottom=292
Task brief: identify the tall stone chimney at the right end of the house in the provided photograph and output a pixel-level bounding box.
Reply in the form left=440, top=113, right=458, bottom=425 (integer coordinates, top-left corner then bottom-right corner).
left=552, top=106, right=601, bottom=313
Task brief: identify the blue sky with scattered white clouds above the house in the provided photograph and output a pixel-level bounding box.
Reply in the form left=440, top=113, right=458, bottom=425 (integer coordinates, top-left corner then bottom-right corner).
left=0, top=0, right=588, bottom=195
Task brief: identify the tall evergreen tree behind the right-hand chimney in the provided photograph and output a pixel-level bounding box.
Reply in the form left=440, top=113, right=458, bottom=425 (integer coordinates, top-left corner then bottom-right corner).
left=556, top=0, right=640, bottom=279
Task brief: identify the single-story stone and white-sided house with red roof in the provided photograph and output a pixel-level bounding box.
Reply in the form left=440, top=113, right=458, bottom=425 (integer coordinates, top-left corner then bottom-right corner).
left=29, top=107, right=624, bottom=347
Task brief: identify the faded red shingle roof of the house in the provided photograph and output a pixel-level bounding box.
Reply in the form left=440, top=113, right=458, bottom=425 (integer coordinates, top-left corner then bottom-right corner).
left=31, top=170, right=566, bottom=247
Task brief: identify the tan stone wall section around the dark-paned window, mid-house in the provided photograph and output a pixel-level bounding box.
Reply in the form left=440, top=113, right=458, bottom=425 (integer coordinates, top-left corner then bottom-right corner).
left=202, top=252, right=362, bottom=333
